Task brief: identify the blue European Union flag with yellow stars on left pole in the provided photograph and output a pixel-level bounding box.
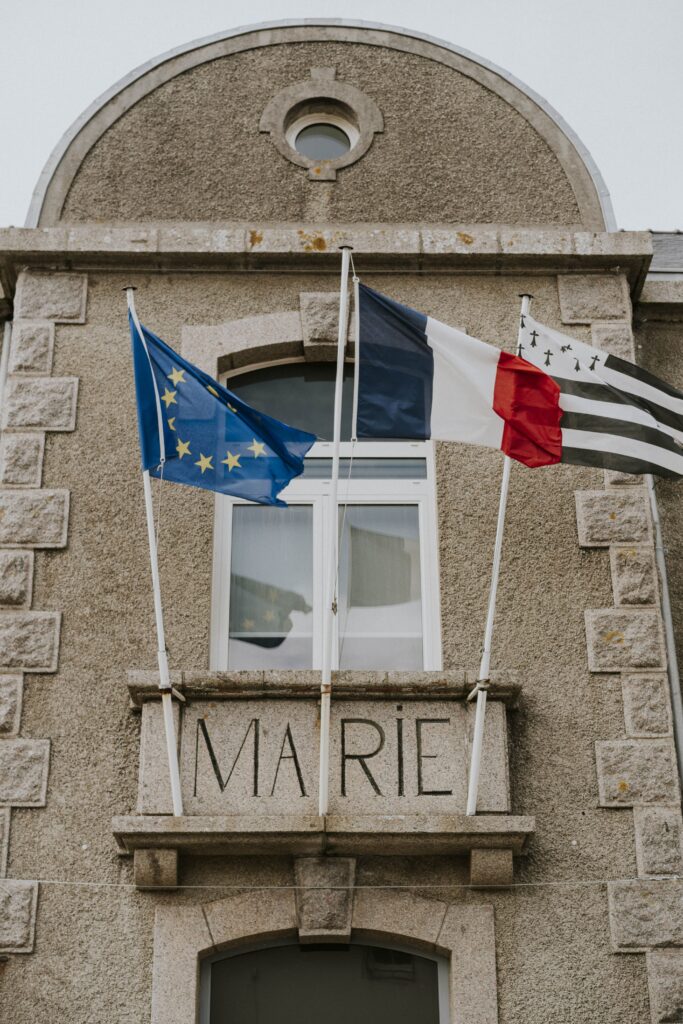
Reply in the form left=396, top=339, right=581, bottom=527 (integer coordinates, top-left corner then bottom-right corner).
left=129, top=313, right=315, bottom=506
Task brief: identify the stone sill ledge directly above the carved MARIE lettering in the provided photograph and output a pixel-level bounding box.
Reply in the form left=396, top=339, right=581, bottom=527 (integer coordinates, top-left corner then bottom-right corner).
left=128, top=669, right=521, bottom=709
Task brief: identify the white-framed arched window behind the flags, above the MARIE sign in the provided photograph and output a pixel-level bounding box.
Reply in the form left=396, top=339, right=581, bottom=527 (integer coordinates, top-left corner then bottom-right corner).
left=211, top=361, right=441, bottom=671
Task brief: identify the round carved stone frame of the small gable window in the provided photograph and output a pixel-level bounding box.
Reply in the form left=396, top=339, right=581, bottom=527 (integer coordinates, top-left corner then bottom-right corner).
left=259, top=68, right=384, bottom=181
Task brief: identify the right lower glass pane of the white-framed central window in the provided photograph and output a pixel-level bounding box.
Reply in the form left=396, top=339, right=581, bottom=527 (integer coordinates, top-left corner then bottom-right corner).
left=339, top=505, right=423, bottom=670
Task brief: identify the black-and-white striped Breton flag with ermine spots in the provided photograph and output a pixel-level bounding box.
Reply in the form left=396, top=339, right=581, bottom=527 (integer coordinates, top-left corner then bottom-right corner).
left=517, top=315, right=683, bottom=477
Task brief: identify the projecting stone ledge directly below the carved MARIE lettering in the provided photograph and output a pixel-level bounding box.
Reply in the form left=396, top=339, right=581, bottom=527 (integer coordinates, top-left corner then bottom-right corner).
left=112, top=814, right=536, bottom=857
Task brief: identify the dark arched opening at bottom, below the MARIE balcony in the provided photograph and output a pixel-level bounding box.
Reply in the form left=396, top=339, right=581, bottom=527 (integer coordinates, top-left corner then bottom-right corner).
left=200, top=944, right=449, bottom=1024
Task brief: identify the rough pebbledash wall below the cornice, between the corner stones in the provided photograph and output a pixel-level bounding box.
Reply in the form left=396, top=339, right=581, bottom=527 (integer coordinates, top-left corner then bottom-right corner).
left=0, top=267, right=656, bottom=1024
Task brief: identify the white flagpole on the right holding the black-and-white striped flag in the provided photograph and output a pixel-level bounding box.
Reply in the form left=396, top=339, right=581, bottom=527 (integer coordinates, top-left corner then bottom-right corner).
left=467, top=295, right=532, bottom=814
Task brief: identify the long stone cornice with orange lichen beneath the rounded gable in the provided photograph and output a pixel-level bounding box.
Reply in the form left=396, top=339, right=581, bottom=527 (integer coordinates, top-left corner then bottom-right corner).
left=0, top=222, right=652, bottom=288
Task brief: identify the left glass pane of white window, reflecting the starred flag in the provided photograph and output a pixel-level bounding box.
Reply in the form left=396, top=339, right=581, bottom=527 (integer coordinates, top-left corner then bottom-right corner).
left=227, top=505, right=313, bottom=669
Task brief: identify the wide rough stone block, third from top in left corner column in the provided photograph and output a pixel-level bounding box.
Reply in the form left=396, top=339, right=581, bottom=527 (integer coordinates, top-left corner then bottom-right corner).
left=2, top=377, right=78, bottom=430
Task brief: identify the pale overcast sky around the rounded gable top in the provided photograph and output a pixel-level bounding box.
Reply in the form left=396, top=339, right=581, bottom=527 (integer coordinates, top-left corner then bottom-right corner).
left=0, top=0, right=683, bottom=229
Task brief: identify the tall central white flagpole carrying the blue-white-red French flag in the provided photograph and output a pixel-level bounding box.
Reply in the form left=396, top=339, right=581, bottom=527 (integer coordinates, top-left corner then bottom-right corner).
left=317, top=246, right=351, bottom=815
